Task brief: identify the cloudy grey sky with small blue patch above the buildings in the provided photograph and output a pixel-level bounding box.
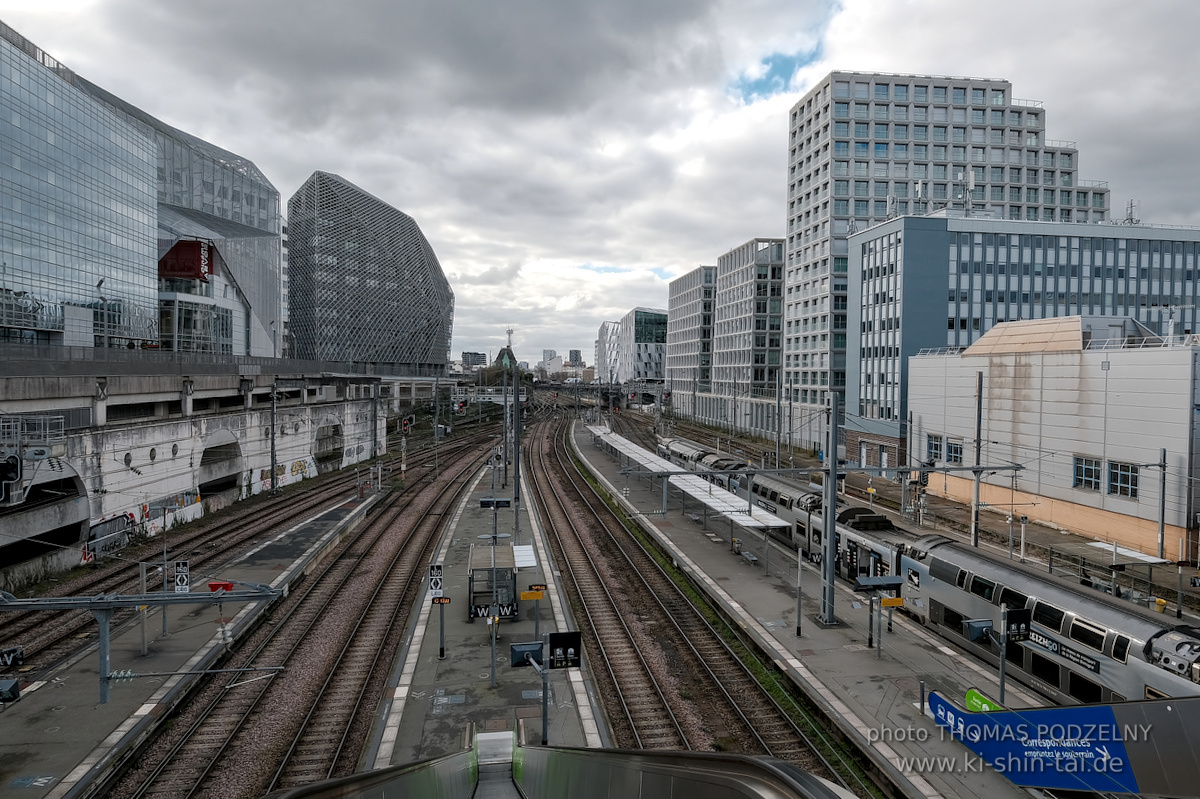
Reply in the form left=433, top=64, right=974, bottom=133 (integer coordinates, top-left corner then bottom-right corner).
left=0, top=0, right=1200, bottom=362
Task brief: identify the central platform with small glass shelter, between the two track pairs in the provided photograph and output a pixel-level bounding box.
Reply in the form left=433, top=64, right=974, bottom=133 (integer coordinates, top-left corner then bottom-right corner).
left=362, top=469, right=611, bottom=769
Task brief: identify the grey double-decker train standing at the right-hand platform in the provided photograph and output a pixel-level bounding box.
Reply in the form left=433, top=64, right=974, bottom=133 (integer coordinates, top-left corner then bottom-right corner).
left=659, top=439, right=1200, bottom=704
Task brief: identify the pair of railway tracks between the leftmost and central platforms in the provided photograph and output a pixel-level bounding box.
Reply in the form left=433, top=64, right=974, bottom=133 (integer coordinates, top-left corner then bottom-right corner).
left=104, top=436, right=486, bottom=798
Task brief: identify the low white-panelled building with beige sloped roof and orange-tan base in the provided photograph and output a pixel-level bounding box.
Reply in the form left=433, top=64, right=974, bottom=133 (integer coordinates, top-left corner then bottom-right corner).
left=908, top=316, right=1200, bottom=559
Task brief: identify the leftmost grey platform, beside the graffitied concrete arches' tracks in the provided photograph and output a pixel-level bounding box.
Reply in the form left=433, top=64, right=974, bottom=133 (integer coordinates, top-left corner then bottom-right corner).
left=0, top=497, right=374, bottom=799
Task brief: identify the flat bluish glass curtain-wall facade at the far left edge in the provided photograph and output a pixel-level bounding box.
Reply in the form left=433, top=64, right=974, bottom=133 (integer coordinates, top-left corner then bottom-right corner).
left=0, top=23, right=158, bottom=347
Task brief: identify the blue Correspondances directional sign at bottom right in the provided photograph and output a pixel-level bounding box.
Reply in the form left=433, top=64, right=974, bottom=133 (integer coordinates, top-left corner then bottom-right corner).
left=929, top=692, right=1148, bottom=793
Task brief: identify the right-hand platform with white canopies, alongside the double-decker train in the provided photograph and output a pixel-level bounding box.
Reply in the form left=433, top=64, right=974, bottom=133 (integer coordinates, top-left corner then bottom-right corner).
left=572, top=423, right=1044, bottom=799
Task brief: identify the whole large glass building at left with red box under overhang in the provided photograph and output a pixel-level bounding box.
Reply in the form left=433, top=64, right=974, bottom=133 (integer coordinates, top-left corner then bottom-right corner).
left=0, top=23, right=283, bottom=355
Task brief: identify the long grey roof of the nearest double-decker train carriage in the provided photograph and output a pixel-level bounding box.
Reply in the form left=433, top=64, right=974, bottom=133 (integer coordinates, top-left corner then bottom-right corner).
left=926, top=539, right=1186, bottom=642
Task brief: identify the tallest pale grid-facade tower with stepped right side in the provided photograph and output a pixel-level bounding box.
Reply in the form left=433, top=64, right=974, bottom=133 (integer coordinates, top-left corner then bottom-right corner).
left=784, top=72, right=1110, bottom=444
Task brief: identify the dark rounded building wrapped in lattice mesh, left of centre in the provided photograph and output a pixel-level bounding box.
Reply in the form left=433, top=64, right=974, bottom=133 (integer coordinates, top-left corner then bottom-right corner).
left=288, top=172, right=454, bottom=376
